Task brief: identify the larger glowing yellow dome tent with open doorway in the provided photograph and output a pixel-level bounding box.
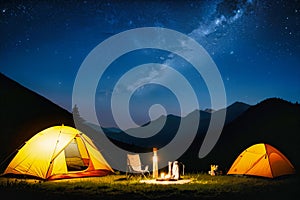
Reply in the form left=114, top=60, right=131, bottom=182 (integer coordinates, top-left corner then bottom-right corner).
left=4, top=125, right=113, bottom=180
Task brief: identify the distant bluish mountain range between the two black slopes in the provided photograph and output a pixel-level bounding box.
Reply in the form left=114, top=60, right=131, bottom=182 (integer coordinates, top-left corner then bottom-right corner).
left=94, top=102, right=250, bottom=149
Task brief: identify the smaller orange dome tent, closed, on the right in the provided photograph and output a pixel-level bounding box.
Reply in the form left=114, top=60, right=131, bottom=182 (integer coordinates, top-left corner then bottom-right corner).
left=227, top=143, right=295, bottom=178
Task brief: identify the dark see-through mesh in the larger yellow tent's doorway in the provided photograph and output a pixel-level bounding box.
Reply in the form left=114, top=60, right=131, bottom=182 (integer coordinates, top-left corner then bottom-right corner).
left=64, top=138, right=88, bottom=171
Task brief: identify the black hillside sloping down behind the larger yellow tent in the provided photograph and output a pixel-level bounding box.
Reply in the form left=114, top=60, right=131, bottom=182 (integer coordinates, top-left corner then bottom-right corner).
left=0, top=73, right=73, bottom=171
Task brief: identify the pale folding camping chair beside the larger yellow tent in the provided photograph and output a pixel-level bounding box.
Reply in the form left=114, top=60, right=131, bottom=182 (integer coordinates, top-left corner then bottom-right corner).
left=126, top=154, right=150, bottom=179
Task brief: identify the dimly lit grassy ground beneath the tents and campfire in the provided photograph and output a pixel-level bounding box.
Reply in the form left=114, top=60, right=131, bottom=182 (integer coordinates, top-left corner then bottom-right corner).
left=0, top=174, right=300, bottom=200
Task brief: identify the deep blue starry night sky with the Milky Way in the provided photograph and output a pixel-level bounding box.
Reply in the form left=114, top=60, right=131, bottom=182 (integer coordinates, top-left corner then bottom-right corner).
left=0, top=0, right=300, bottom=126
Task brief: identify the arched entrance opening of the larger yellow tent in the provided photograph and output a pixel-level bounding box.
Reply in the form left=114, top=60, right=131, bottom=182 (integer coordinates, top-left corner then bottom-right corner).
left=64, top=137, right=89, bottom=171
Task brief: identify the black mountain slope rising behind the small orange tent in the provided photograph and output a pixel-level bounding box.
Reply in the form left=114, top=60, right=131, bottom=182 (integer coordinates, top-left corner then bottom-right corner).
left=181, top=98, right=300, bottom=172
